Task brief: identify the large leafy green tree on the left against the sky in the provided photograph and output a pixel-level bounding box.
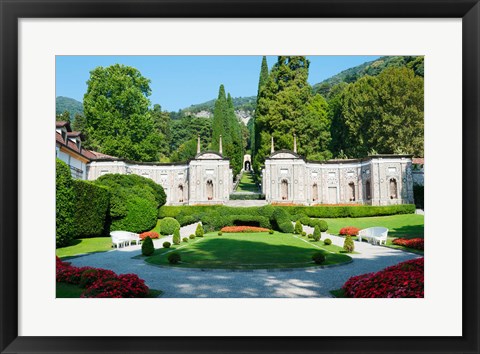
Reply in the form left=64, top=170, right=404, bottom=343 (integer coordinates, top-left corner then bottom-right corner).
left=83, top=64, right=161, bottom=161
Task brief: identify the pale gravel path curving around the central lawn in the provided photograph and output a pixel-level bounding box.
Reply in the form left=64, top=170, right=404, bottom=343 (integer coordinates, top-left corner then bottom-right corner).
left=69, top=224, right=419, bottom=298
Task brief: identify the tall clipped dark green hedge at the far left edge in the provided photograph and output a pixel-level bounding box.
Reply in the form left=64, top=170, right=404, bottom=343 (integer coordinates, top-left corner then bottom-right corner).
left=55, top=159, right=75, bottom=247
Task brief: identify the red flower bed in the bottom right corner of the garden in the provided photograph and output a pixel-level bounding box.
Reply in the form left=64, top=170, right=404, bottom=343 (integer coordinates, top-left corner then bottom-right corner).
left=342, top=258, right=424, bottom=298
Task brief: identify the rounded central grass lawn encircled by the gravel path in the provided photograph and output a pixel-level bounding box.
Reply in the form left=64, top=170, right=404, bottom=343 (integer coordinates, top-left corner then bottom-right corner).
left=146, top=232, right=351, bottom=269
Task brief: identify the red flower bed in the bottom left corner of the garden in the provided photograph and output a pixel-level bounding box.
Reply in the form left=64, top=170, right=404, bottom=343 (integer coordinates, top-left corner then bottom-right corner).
left=56, top=257, right=149, bottom=298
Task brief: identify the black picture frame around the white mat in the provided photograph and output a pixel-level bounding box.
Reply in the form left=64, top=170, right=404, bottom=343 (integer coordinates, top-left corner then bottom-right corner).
left=0, top=0, right=480, bottom=353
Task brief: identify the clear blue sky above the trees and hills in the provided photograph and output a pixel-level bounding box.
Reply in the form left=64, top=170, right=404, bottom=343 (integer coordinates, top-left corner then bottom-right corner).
left=56, top=56, right=378, bottom=111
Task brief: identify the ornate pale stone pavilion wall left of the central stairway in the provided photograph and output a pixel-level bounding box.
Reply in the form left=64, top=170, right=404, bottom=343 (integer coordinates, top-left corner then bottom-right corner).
left=88, top=137, right=233, bottom=205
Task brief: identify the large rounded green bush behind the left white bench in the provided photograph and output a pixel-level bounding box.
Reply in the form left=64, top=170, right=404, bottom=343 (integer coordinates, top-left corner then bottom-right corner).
left=94, top=174, right=166, bottom=233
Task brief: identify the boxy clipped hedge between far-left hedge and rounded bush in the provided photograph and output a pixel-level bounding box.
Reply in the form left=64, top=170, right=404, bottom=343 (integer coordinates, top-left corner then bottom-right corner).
left=73, top=180, right=110, bottom=238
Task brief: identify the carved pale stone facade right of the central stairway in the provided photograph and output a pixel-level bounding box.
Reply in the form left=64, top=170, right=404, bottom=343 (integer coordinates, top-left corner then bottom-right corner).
left=262, top=150, right=413, bottom=205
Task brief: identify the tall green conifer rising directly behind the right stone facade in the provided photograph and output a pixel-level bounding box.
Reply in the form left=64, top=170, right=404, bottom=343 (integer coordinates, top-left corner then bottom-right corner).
left=254, top=56, right=330, bottom=170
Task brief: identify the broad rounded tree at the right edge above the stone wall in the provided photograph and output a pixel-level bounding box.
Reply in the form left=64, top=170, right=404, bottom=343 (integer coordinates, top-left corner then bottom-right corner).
left=332, top=67, right=424, bottom=157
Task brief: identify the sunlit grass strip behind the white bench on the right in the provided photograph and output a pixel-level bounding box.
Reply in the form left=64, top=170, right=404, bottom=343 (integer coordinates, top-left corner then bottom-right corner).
left=325, top=214, right=424, bottom=238
